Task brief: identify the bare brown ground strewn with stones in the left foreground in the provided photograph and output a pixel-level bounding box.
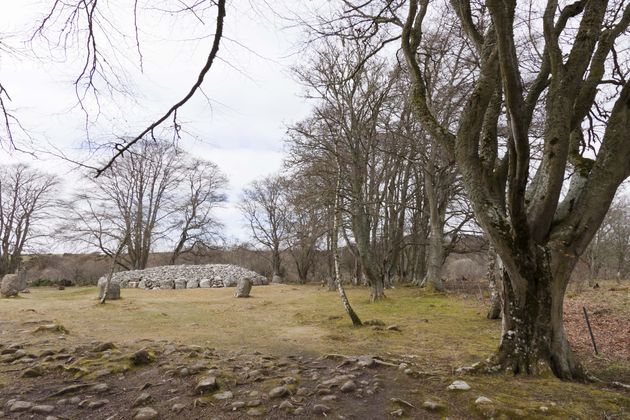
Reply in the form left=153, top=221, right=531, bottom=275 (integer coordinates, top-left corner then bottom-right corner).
left=0, top=334, right=470, bottom=420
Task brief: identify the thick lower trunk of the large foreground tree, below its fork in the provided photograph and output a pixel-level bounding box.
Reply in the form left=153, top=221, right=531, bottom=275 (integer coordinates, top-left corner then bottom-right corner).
left=497, top=247, right=586, bottom=380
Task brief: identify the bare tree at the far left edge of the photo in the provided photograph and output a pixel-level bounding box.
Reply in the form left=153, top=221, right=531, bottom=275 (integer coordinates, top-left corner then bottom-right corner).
left=0, top=164, right=59, bottom=277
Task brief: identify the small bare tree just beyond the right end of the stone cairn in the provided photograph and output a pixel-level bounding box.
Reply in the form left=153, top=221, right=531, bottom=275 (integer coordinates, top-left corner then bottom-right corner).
left=239, top=176, right=288, bottom=283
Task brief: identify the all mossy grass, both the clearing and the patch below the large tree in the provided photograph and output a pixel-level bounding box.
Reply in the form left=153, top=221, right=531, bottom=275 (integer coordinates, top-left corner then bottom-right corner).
left=0, top=285, right=630, bottom=418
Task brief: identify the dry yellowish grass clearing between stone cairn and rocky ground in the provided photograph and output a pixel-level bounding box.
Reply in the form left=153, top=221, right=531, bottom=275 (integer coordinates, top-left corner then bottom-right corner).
left=0, top=285, right=498, bottom=365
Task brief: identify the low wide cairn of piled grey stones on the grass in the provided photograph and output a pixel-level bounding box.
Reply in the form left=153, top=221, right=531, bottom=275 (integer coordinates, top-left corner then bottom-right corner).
left=99, top=264, right=268, bottom=289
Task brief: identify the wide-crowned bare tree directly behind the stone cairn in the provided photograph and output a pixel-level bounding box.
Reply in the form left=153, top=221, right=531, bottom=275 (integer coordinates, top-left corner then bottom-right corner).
left=62, top=141, right=226, bottom=269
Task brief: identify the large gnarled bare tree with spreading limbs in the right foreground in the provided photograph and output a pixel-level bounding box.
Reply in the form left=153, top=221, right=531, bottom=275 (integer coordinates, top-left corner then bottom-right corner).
left=316, top=0, right=630, bottom=379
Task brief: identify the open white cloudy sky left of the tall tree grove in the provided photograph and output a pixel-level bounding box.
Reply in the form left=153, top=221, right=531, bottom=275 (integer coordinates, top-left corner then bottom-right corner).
left=0, top=0, right=310, bottom=246
